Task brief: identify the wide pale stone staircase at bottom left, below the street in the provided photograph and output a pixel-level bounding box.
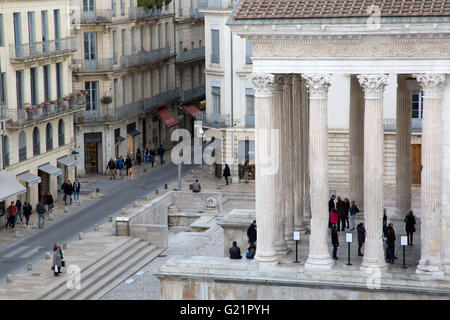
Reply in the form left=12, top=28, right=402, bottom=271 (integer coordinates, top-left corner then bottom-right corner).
left=39, top=237, right=165, bottom=300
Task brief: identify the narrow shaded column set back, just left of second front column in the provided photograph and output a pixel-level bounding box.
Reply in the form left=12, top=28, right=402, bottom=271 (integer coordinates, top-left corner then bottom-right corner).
left=292, top=74, right=306, bottom=231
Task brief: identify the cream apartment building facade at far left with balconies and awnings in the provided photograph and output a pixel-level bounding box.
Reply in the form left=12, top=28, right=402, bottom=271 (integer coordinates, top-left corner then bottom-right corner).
left=0, top=0, right=85, bottom=212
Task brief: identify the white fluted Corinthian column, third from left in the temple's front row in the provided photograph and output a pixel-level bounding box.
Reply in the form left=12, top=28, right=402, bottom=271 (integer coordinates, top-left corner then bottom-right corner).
left=358, top=74, right=388, bottom=270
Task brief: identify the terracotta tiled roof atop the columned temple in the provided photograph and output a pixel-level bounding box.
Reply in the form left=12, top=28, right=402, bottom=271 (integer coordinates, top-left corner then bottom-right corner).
left=233, top=0, right=450, bottom=20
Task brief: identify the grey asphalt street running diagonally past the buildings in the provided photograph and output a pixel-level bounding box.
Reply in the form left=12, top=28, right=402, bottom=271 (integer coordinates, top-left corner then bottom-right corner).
left=0, top=160, right=195, bottom=283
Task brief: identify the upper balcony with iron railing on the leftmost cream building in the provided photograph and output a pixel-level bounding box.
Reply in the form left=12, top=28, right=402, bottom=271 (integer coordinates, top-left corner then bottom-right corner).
left=9, top=36, right=77, bottom=62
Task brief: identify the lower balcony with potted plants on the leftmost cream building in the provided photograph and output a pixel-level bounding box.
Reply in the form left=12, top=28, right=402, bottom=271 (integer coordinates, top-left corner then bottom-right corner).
left=6, top=94, right=86, bottom=127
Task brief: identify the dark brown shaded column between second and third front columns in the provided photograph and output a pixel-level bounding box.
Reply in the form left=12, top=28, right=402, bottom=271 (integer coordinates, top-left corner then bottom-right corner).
left=349, top=75, right=364, bottom=211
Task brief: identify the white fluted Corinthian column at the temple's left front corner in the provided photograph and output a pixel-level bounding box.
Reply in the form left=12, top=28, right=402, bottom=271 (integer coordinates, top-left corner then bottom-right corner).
left=250, top=73, right=280, bottom=268
